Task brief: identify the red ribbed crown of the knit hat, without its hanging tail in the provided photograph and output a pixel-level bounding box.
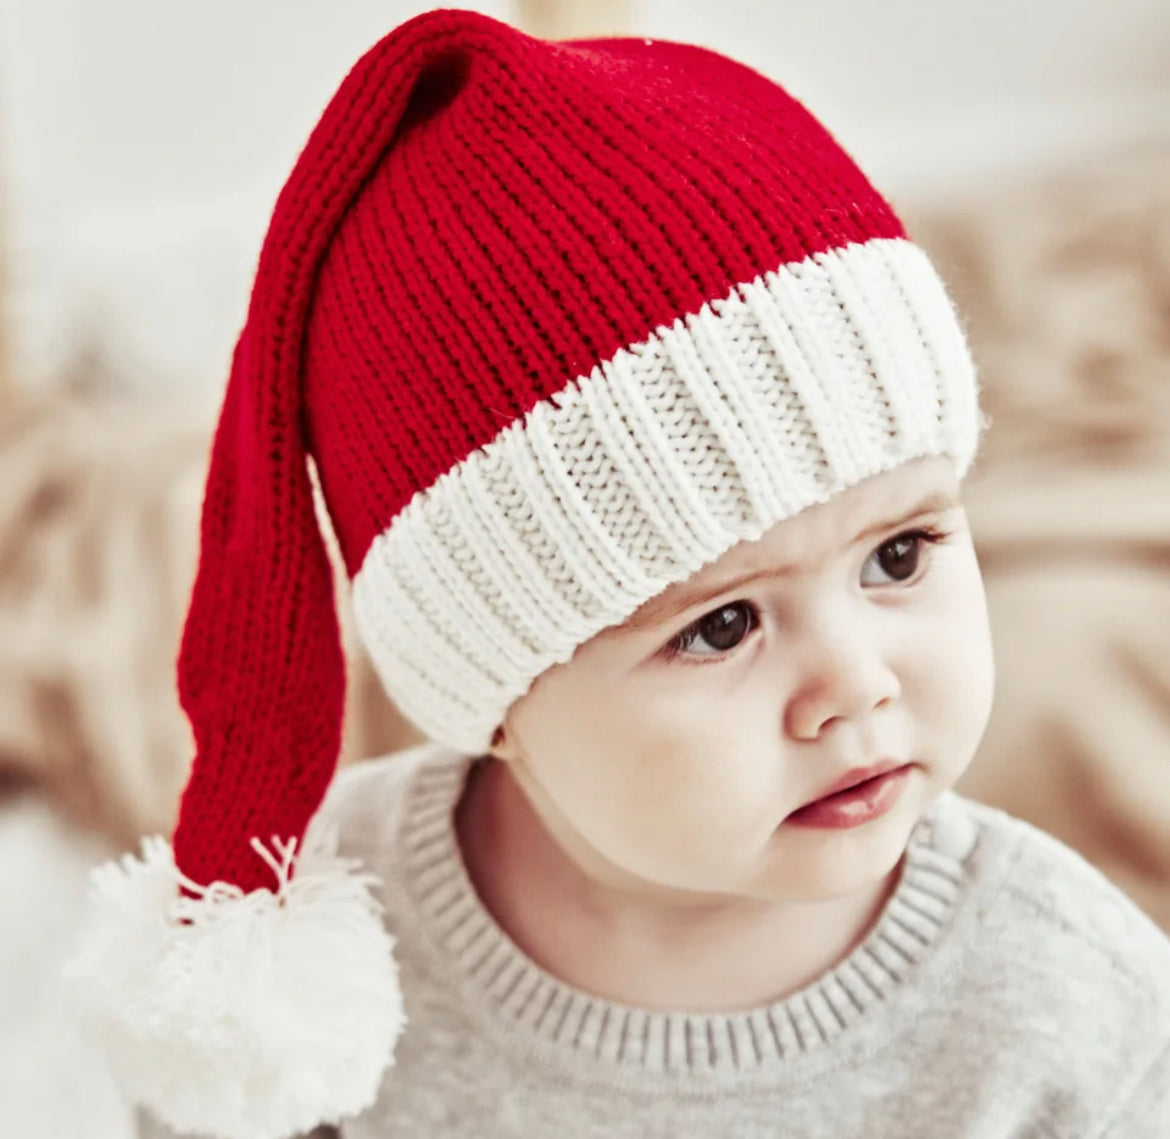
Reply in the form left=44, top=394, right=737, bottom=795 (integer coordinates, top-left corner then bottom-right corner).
left=305, top=15, right=903, bottom=574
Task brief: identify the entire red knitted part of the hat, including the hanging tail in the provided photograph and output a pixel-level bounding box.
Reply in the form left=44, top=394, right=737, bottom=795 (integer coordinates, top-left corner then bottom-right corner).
left=174, top=11, right=904, bottom=889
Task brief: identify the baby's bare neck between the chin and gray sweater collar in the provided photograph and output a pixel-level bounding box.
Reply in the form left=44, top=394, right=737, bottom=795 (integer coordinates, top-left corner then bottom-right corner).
left=456, top=761, right=900, bottom=1013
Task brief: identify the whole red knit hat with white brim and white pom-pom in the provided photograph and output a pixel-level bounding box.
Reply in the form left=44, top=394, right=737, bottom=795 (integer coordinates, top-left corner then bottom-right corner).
left=61, top=11, right=983, bottom=1139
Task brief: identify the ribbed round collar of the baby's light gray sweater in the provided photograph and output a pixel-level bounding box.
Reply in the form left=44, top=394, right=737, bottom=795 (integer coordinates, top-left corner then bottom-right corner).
left=398, top=753, right=973, bottom=1077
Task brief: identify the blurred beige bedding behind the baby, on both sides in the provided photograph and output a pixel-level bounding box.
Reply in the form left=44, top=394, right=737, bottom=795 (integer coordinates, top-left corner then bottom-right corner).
left=0, top=147, right=1170, bottom=930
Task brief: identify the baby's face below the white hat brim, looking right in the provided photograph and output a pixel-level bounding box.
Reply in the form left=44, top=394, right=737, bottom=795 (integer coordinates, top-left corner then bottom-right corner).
left=496, top=458, right=995, bottom=900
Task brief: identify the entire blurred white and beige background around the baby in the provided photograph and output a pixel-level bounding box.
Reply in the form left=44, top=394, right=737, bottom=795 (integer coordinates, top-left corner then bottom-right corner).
left=0, top=0, right=1170, bottom=1139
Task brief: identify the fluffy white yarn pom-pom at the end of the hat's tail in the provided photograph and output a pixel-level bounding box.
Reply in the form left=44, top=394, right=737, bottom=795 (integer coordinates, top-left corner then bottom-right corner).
left=67, top=830, right=406, bottom=1139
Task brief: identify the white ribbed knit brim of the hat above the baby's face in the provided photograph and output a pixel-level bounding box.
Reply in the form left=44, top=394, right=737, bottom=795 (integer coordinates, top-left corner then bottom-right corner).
left=353, top=240, right=983, bottom=752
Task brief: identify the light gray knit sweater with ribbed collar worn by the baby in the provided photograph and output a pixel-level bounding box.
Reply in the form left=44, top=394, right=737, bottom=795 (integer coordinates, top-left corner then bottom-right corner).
left=142, top=745, right=1170, bottom=1139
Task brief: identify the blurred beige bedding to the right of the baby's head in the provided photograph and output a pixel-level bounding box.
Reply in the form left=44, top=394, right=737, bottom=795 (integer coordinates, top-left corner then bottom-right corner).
left=913, top=151, right=1170, bottom=930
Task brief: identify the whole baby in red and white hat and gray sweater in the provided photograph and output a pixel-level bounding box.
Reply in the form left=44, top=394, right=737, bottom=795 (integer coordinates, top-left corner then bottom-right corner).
left=71, top=11, right=1170, bottom=1139
